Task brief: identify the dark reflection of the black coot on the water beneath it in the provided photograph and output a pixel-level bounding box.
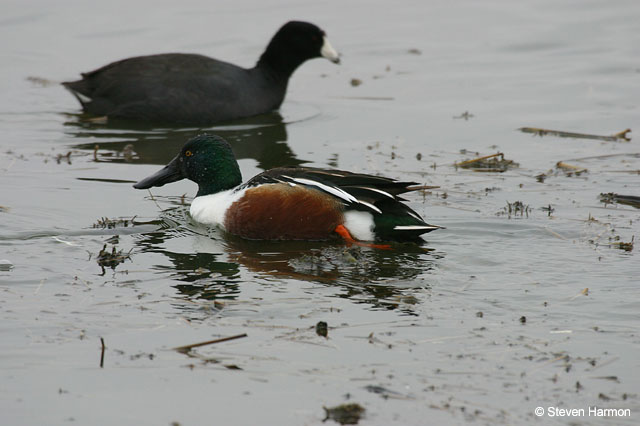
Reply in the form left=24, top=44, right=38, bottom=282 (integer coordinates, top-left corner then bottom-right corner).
left=65, top=112, right=304, bottom=170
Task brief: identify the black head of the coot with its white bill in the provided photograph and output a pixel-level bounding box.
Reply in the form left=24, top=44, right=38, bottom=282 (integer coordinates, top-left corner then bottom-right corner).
left=258, top=21, right=340, bottom=77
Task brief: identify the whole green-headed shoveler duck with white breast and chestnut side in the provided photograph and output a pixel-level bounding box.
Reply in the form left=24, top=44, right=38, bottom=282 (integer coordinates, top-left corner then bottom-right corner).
left=134, top=135, right=439, bottom=248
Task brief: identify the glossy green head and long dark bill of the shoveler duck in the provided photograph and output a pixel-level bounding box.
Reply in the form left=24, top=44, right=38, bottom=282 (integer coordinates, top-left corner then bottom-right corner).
left=133, top=134, right=242, bottom=196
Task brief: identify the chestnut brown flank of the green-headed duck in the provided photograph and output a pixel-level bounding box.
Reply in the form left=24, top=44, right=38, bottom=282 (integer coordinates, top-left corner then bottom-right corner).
left=224, top=184, right=344, bottom=240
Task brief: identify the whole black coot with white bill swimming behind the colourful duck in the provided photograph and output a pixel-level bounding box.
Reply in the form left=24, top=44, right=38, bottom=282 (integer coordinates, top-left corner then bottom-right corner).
left=62, top=21, right=340, bottom=124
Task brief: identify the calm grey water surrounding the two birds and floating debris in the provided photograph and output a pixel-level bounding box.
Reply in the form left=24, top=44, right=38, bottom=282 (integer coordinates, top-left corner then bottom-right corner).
left=0, top=0, right=640, bottom=425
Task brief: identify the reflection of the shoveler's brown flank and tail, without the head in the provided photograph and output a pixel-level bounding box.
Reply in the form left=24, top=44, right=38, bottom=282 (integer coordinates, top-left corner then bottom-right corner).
left=225, top=234, right=442, bottom=314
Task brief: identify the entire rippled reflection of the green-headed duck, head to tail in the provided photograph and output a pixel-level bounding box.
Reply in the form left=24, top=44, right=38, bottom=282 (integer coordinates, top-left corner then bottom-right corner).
left=136, top=206, right=443, bottom=314
